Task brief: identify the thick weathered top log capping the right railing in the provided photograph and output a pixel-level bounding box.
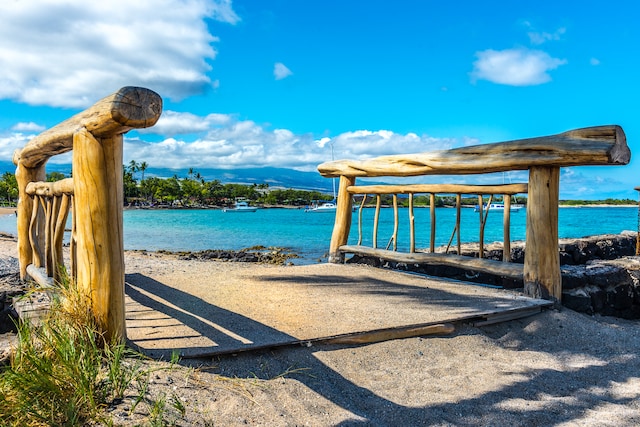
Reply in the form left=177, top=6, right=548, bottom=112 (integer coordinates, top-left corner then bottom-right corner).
left=318, top=125, right=631, bottom=178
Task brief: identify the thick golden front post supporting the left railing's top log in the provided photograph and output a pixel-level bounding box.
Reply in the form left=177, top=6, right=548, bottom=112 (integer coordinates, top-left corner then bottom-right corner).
left=73, top=128, right=126, bottom=340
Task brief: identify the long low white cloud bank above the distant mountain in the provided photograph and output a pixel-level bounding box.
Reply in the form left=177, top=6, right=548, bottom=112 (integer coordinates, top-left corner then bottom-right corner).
left=124, top=112, right=460, bottom=171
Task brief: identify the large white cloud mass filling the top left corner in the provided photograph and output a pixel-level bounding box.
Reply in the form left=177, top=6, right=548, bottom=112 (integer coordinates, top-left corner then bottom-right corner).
left=0, top=0, right=239, bottom=107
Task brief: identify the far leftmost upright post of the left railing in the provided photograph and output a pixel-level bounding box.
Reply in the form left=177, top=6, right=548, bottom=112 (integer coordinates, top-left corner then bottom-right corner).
left=16, top=163, right=46, bottom=280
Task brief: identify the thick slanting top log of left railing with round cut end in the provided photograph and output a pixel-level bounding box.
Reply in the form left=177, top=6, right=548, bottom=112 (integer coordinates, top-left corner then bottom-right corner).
left=13, top=86, right=162, bottom=168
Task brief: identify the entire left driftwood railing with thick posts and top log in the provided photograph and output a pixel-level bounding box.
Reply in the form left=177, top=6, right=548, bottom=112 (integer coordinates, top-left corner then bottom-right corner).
left=13, top=87, right=162, bottom=339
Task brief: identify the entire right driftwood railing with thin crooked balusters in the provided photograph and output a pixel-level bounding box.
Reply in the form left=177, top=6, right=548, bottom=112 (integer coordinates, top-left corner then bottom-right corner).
left=318, top=125, right=631, bottom=303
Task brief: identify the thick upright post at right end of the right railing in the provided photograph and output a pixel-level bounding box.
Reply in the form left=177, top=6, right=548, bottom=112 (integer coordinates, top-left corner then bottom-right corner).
left=524, top=166, right=562, bottom=305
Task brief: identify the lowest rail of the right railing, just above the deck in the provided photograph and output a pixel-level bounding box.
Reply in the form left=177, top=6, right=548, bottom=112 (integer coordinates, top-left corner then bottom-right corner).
left=339, top=245, right=524, bottom=280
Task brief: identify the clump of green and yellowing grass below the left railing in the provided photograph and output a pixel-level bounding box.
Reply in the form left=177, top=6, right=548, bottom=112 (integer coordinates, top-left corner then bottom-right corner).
left=0, top=274, right=175, bottom=427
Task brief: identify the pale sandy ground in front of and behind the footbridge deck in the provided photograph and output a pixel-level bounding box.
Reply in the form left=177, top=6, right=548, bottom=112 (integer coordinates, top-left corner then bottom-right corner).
left=0, top=238, right=640, bottom=426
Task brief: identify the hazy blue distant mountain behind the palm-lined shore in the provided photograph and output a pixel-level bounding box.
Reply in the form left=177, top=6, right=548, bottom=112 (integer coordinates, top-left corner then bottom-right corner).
left=0, top=160, right=332, bottom=193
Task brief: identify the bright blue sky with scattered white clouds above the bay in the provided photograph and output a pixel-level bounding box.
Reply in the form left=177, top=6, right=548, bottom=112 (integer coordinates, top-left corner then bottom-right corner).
left=0, top=0, right=640, bottom=199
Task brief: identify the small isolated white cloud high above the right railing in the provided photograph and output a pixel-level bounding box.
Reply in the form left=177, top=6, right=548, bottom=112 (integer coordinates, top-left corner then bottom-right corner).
left=471, top=49, right=567, bottom=86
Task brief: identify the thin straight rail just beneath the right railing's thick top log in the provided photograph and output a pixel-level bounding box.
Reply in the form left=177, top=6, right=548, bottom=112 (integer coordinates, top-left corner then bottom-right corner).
left=347, top=184, right=528, bottom=195
